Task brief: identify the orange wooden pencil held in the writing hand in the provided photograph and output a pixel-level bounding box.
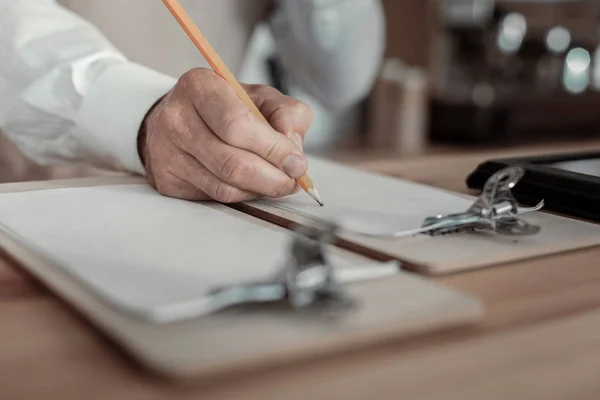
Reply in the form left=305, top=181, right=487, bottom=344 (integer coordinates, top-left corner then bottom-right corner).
left=157, top=0, right=323, bottom=206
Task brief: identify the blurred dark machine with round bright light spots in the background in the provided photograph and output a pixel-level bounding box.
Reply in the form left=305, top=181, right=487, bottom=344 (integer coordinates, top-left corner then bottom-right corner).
left=429, top=0, right=600, bottom=144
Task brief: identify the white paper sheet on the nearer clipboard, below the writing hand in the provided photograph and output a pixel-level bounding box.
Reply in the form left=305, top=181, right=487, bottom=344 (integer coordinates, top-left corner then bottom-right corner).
left=0, top=185, right=384, bottom=320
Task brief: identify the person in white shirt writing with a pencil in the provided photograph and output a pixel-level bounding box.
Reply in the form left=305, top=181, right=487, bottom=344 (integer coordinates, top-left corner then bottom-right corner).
left=0, top=0, right=385, bottom=202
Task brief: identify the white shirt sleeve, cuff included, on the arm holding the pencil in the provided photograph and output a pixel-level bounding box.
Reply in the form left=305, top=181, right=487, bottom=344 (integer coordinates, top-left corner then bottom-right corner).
left=0, top=0, right=176, bottom=174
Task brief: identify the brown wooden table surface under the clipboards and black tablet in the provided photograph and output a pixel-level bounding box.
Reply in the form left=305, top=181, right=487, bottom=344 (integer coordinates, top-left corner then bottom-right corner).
left=0, top=142, right=600, bottom=400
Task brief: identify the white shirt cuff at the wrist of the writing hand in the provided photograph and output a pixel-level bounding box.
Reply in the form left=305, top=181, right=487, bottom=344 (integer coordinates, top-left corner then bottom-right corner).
left=79, top=63, right=176, bottom=175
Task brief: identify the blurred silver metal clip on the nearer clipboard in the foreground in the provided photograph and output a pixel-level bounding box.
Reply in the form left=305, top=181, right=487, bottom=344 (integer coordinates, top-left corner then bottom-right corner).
left=206, top=223, right=400, bottom=314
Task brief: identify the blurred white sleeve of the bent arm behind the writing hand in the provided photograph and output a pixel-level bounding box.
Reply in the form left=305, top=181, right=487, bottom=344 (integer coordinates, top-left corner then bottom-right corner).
left=269, top=0, right=386, bottom=111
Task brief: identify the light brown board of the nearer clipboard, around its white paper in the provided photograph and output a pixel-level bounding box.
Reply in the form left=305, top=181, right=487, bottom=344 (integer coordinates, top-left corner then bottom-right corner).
left=0, top=178, right=484, bottom=381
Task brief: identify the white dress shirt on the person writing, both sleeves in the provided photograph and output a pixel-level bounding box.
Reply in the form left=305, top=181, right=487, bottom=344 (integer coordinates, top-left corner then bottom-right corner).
left=0, top=0, right=384, bottom=174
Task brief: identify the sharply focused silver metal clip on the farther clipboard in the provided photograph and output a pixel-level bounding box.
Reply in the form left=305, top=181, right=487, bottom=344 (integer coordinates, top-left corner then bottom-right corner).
left=423, top=167, right=544, bottom=236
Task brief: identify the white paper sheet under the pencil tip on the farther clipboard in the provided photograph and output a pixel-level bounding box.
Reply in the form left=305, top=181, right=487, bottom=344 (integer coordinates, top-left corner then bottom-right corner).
left=251, top=158, right=474, bottom=235
